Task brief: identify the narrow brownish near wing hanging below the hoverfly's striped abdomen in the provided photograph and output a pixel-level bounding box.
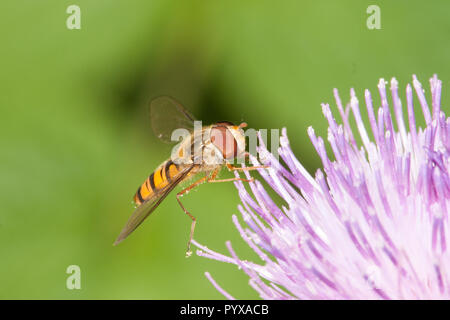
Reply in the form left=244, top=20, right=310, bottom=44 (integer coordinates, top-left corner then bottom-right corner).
left=114, top=165, right=194, bottom=245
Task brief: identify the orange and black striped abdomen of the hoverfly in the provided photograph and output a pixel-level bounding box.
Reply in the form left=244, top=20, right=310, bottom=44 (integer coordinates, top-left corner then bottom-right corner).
left=134, top=160, right=179, bottom=206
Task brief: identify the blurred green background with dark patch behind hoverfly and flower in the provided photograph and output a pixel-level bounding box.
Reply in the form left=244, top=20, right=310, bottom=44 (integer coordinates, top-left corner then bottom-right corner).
left=0, top=0, right=450, bottom=299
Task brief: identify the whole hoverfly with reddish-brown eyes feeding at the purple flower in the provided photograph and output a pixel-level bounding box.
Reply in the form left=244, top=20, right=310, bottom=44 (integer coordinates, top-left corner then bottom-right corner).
left=114, top=96, right=266, bottom=257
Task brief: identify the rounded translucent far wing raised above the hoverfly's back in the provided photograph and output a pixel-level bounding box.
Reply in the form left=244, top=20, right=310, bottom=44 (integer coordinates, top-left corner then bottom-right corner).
left=150, top=96, right=195, bottom=142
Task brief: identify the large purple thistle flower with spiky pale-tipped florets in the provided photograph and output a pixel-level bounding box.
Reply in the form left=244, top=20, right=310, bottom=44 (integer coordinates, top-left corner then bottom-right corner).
left=195, top=75, right=450, bottom=299
